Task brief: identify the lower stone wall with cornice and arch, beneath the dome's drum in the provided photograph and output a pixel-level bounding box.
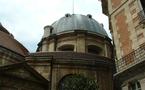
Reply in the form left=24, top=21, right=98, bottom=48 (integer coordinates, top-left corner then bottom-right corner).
left=26, top=52, right=113, bottom=90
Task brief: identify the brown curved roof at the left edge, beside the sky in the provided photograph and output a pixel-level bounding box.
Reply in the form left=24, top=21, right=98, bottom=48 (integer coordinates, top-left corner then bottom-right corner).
left=0, top=24, right=28, bottom=56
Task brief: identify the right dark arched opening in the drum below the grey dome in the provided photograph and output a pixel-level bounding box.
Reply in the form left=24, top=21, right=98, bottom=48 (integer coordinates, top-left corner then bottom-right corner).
left=88, top=45, right=102, bottom=55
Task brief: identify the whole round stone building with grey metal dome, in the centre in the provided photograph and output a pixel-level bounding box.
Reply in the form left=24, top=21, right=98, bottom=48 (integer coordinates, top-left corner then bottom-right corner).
left=26, top=14, right=114, bottom=90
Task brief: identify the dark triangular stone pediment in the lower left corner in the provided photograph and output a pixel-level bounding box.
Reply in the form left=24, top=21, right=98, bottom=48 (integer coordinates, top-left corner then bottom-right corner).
left=0, top=63, right=49, bottom=90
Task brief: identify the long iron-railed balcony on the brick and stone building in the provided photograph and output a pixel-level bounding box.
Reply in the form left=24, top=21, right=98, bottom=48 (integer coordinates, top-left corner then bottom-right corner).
left=116, top=43, right=145, bottom=73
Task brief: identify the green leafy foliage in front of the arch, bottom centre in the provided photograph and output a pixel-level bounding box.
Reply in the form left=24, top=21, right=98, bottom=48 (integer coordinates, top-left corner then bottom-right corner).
left=59, top=75, right=98, bottom=90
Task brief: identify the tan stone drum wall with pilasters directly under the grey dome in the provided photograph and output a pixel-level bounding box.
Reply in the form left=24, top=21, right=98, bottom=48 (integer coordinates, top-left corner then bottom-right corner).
left=38, top=32, right=112, bottom=58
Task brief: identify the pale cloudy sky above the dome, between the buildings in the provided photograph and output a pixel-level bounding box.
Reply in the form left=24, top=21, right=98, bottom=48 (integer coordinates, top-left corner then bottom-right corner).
left=0, top=0, right=108, bottom=52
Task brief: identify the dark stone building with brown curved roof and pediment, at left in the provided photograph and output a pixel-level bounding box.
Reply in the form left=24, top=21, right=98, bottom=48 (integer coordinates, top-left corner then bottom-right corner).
left=0, top=25, right=49, bottom=90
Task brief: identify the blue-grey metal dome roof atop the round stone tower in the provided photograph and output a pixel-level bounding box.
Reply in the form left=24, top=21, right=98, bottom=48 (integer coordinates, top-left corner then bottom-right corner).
left=49, top=14, right=108, bottom=36
